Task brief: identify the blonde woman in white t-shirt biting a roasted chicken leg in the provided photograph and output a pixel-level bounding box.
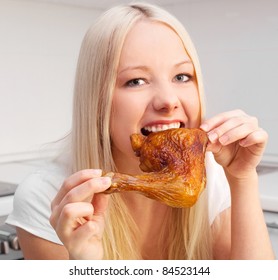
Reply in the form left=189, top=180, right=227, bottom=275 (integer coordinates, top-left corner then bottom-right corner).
left=7, top=3, right=274, bottom=259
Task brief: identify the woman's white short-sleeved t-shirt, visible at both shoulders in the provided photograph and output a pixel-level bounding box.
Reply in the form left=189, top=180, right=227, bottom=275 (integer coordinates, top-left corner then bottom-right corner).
left=6, top=153, right=231, bottom=244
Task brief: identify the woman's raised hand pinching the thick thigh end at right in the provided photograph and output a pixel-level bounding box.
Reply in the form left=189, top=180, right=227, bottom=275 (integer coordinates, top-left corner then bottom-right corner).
left=200, top=110, right=268, bottom=179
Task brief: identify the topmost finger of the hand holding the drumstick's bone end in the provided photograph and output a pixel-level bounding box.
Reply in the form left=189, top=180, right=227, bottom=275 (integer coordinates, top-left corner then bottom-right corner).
left=51, top=169, right=102, bottom=209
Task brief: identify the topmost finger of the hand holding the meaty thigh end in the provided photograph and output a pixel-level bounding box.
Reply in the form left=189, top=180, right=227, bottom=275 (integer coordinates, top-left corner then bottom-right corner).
left=200, top=110, right=247, bottom=132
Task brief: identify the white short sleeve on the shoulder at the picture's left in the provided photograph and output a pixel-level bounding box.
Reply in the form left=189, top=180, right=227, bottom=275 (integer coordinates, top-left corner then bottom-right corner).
left=6, top=165, right=64, bottom=244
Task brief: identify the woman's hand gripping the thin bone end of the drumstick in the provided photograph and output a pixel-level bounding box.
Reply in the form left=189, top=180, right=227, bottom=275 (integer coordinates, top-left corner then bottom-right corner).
left=50, top=169, right=111, bottom=259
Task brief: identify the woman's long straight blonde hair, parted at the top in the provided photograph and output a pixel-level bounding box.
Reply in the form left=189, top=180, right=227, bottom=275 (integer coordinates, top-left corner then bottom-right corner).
left=71, top=3, right=212, bottom=259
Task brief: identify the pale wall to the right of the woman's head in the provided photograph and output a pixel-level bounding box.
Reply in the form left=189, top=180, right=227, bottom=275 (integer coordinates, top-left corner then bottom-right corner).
left=169, top=0, right=278, bottom=162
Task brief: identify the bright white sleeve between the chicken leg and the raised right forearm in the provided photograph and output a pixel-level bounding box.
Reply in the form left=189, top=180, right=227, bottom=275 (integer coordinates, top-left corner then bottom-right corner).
left=206, top=152, right=231, bottom=224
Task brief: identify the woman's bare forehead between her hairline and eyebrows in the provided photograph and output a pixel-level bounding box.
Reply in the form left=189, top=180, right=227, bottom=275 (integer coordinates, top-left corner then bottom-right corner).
left=120, top=20, right=189, bottom=64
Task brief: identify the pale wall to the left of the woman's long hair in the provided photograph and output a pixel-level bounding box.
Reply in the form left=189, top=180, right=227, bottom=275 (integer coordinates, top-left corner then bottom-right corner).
left=0, top=0, right=99, bottom=162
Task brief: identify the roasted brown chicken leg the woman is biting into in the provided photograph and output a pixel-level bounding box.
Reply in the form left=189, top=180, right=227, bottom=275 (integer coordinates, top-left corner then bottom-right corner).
left=106, top=128, right=208, bottom=207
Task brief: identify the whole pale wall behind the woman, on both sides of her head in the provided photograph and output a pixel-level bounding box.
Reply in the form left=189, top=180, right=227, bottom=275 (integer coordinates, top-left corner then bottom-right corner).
left=0, top=0, right=278, bottom=162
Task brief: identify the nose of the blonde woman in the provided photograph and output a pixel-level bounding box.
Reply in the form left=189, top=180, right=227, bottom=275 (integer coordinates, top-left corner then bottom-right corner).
left=152, top=86, right=180, bottom=113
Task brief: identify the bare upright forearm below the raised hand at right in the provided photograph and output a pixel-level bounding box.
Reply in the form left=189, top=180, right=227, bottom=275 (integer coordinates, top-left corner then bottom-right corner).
left=227, top=171, right=274, bottom=259
